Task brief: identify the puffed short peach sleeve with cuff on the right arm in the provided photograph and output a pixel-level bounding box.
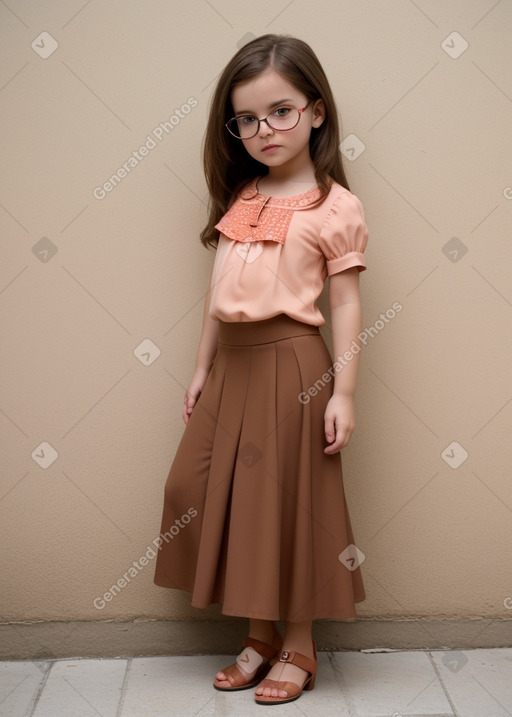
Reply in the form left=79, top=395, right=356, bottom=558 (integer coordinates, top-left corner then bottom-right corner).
left=318, top=190, right=368, bottom=276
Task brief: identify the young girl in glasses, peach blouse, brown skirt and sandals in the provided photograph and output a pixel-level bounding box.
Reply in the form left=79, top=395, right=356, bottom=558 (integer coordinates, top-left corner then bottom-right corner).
left=155, top=35, right=368, bottom=704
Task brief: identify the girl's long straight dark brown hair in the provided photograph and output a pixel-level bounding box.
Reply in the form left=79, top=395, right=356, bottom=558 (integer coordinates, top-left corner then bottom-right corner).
left=201, top=34, right=350, bottom=246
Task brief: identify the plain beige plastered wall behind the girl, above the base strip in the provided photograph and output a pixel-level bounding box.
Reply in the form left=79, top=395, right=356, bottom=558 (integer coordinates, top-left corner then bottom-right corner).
left=0, top=0, right=512, bottom=621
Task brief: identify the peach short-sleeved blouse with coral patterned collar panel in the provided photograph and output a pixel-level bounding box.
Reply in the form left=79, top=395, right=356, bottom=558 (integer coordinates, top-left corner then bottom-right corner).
left=209, top=177, right=368, bottom=326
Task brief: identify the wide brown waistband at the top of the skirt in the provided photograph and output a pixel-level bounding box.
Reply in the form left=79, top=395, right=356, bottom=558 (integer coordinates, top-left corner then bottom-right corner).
left=218, top=314, right=321, bottom=346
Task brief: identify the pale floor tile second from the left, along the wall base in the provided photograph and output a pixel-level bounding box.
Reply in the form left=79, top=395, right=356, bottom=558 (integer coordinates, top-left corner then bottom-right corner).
left=32, top=659, right=127, bottom=717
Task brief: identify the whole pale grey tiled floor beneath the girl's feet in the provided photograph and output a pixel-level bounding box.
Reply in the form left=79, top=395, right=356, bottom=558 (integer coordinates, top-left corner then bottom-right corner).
left=0, top=648, right=512, bottom=717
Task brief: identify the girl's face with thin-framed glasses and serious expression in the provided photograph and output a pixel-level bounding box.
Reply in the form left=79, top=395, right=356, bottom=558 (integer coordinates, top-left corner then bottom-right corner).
left=231, top=67, right=325, bottom=170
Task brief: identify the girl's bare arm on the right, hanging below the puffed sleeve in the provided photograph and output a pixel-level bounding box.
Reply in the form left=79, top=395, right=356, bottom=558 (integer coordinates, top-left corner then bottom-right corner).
left=324, top=267, right=361, bottom=454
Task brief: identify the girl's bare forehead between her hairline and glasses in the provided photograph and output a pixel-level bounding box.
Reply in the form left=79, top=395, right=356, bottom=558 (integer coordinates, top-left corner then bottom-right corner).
left=231, top=67, right=303, bottom=112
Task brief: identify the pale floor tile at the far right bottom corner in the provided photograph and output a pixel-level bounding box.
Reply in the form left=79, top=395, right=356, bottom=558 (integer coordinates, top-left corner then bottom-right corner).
left=431, top=647, right=512, bottom=717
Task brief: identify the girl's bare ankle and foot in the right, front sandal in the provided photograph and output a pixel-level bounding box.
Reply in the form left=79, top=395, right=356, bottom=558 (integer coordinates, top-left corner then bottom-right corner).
left=256, top=620, right=315, bottom=699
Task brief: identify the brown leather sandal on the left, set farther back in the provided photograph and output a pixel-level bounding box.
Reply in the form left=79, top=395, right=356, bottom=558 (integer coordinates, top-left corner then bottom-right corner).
left=213, top=624, right=283, bottom=692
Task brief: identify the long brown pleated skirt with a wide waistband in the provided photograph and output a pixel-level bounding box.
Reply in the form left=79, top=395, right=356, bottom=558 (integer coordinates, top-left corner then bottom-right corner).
left=154, top=314, right=365, bottom=622
